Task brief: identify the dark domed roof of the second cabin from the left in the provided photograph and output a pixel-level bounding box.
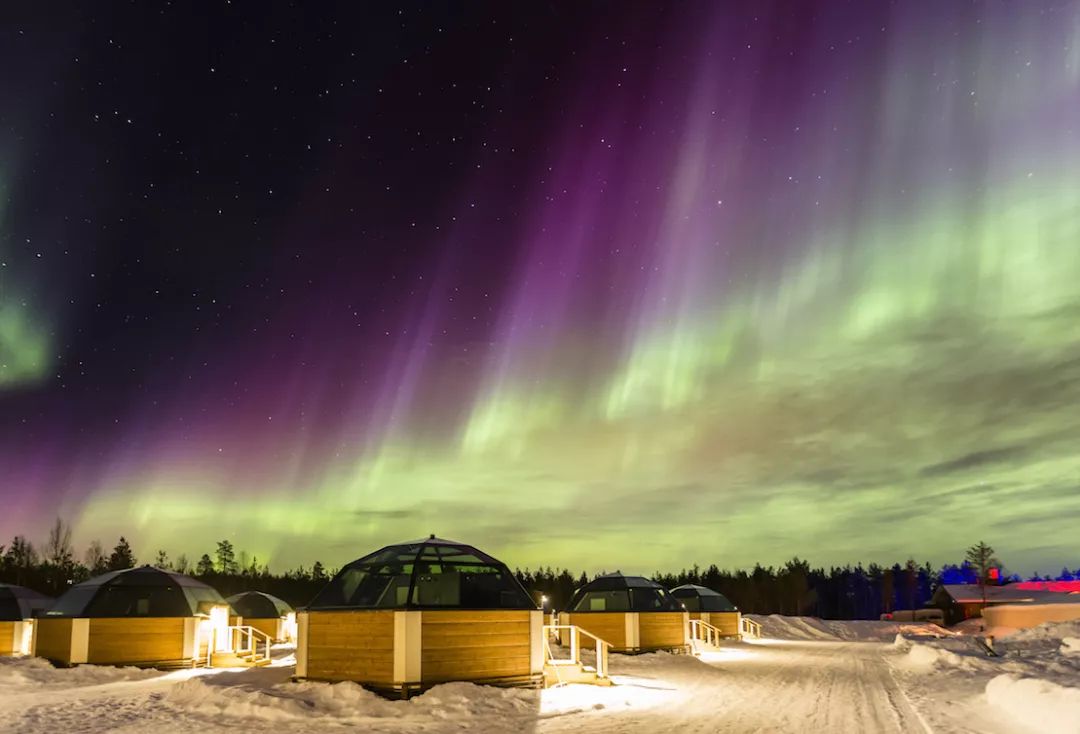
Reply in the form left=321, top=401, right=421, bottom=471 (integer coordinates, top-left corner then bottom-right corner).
left=46, top=566, right=228, bottom=617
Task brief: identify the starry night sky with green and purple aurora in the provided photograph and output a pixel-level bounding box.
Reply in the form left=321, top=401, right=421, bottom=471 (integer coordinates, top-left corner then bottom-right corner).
left=0, top=0, right=1080, bottom=572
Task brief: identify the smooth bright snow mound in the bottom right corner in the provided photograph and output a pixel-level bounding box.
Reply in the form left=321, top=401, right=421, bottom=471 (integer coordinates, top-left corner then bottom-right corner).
left=986, top=675, right=1080, bottom=734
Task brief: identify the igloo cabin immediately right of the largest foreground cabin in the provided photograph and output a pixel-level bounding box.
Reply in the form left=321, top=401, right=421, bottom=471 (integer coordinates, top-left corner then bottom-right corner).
left=558, top=572, right=690, bottom=653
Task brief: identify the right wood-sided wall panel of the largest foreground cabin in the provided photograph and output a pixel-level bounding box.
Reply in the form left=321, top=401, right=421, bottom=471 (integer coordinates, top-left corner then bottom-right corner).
left=420, top=611, right=530, bottom=684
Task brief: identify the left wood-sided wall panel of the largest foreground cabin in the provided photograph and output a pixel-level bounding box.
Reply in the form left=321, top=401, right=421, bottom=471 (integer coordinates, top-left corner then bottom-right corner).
left=308, top=610, right=394, bottom=687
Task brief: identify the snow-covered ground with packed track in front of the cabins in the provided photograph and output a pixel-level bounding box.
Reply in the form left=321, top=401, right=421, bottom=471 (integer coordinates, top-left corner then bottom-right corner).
left=0, top=616, right=1080, bottom=734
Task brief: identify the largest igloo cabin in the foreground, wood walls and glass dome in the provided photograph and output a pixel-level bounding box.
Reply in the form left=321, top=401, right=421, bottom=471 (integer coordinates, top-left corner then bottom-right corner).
left=296, top=535, right=543, bottom=697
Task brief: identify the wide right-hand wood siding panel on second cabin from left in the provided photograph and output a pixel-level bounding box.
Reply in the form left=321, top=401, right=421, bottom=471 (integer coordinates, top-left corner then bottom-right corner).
left=86, top=616, right=185, bottom=665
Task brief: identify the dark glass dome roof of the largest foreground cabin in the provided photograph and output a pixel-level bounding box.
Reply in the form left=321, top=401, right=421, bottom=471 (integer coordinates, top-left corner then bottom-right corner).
left=308, top=535, right=537, bottom=610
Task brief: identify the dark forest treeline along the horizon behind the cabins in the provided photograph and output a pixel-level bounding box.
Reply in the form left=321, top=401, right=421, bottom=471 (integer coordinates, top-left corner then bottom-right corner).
left=0, top=520, right=1080, bottom=620
